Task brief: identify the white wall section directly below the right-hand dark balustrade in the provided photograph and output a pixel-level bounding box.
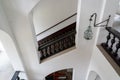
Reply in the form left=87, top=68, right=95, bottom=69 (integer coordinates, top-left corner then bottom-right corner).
left=86, top=47, right=120, bottom=80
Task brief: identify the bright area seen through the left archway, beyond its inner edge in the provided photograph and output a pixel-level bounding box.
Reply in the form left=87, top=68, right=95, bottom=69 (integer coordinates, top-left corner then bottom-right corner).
left=0, top=52, right=14, bottom=80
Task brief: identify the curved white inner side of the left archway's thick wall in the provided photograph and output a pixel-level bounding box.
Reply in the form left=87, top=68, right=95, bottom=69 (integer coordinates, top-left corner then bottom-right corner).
left=0, top=30, right=24, bottom=71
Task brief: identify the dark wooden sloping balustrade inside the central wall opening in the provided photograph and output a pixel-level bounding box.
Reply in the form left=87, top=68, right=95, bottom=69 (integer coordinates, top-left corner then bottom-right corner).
left=38, top=22, right=76, bottom=60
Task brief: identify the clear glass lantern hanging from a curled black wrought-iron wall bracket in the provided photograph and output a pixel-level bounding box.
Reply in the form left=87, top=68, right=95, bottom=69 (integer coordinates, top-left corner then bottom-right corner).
left=84, top=13, right=111, bottom=40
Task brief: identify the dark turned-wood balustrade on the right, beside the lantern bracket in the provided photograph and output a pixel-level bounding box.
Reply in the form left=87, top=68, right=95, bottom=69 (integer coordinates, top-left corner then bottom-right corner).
left=101, top=27, right=120, bottom=67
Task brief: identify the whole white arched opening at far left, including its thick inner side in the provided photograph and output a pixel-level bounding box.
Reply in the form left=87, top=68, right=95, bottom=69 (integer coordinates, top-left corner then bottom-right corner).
left=0, top=30, right=24, bottom=80
